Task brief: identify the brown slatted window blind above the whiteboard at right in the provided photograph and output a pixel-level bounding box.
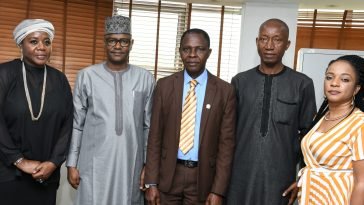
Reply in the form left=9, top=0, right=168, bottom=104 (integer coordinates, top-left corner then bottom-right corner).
left=296, top=9, right=364, bottom=67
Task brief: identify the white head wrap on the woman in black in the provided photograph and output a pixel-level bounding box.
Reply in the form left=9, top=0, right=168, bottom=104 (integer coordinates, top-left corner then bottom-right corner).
left=13, top=19, right=55, bottom=45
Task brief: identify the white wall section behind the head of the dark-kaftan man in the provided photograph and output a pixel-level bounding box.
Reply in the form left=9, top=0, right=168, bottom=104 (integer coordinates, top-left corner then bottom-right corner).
left=238, top=2, right=298, bottom=72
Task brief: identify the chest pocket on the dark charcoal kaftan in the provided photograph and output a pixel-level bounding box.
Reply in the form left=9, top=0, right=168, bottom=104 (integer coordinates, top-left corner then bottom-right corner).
left=273, top=96, right=298, bottom=125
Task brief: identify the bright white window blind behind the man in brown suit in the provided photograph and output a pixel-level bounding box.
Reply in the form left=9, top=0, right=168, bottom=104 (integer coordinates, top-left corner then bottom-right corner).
left=114, top=0, right=241, bottom=81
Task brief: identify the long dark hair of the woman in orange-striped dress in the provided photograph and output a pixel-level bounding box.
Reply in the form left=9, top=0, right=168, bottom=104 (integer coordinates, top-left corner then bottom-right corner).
left=311, top=55, right=364, bottom=128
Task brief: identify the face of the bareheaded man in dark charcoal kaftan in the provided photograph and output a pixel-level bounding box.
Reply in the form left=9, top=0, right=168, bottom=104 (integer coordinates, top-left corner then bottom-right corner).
left=256, top=21, right=291, bottom=66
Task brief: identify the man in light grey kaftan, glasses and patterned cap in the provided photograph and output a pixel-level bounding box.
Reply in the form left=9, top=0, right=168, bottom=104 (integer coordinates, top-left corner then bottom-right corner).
left=66, top=16, right=155, bottom=205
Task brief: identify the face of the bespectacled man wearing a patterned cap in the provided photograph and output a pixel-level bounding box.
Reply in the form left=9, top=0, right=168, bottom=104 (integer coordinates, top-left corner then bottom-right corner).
left=105, top=34, right=133, bottom=65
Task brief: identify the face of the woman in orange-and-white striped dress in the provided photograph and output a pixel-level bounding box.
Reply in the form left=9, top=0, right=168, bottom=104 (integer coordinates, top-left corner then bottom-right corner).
left=324, top=61, right=360, bottom=104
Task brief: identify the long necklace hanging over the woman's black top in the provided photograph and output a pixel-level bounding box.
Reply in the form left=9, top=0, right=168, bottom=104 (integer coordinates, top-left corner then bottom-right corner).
left=22, top=62, right=47, bottom=121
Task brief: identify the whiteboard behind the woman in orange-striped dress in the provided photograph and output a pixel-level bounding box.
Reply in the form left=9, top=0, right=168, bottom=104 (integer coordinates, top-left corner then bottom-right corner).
left=296, top=48, right=364, bottom=109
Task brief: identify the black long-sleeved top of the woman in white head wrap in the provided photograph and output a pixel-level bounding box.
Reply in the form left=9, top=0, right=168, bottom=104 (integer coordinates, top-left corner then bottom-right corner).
left=0, top=59, right=73, bottom=182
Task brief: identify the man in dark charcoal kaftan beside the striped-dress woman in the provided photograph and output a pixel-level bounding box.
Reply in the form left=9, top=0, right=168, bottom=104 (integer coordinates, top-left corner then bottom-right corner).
left=227, top=19, right=316, bottom=205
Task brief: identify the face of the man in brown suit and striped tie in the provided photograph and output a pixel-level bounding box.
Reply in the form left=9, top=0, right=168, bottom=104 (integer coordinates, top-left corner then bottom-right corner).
left=179, top=33, right=211, bottom=78
